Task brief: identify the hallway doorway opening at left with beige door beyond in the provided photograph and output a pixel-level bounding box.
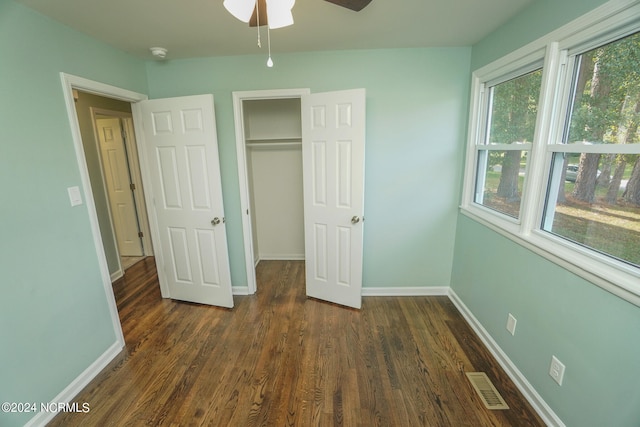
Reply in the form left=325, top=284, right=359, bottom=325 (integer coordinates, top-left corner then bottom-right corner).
left=74, top=90, right=153, bottom=282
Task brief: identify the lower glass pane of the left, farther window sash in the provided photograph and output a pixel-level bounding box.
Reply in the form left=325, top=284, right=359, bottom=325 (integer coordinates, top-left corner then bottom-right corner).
left=474, top=150, right=528, bottom=218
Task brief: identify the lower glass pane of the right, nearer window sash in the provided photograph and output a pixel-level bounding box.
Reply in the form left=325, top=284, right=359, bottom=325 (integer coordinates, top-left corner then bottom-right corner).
left=542, top=153, right=640, bottom=266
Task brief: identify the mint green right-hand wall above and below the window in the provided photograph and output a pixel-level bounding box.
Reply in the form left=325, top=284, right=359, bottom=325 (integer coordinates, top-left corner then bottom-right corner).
left=451, top=0, right=640, bottom=427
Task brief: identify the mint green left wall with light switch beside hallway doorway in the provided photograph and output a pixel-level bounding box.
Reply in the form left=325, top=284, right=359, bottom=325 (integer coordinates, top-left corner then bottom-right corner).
left=0, top=0, right=146, bottom=426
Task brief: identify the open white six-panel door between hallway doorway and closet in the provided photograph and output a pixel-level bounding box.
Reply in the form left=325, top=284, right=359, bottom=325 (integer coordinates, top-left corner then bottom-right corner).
left=134, top=95, right=233, bottom=307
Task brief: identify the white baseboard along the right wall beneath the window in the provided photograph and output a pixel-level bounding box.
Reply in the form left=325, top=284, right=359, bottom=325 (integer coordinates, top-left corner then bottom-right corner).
left=449, top=289, right=565, bottom=427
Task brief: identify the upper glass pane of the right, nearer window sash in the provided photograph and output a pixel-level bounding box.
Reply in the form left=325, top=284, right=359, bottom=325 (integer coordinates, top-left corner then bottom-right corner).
left=564, top=33, right=640, bottom=144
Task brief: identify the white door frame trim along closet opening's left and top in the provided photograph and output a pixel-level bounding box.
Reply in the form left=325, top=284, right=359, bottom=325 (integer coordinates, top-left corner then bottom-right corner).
left=232, top=88, right=311, bottom=295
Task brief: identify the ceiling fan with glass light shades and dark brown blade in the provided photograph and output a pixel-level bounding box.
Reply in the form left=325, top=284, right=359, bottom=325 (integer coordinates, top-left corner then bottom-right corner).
left=224, top=0, right=371, bottom=29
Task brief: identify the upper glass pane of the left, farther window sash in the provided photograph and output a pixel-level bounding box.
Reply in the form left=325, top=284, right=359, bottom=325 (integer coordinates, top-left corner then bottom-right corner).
left=485, top=69, right=542, bottom=144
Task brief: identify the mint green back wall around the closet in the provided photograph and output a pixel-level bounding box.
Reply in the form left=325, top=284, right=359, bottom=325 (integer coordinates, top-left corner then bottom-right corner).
left=148, top=48, right=470, bottom=287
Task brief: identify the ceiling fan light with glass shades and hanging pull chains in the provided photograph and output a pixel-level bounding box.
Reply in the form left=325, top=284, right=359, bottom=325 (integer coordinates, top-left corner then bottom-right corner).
left=223, top=0, right=295, bottom=67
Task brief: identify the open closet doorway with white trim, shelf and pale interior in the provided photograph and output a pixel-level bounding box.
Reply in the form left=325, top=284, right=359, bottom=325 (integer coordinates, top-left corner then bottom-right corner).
left=233, top=89, right=310, bottom=294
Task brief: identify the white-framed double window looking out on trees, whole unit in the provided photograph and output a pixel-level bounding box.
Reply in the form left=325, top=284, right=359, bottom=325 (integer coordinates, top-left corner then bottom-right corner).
left=461, top=2, right=640, bottom=305
